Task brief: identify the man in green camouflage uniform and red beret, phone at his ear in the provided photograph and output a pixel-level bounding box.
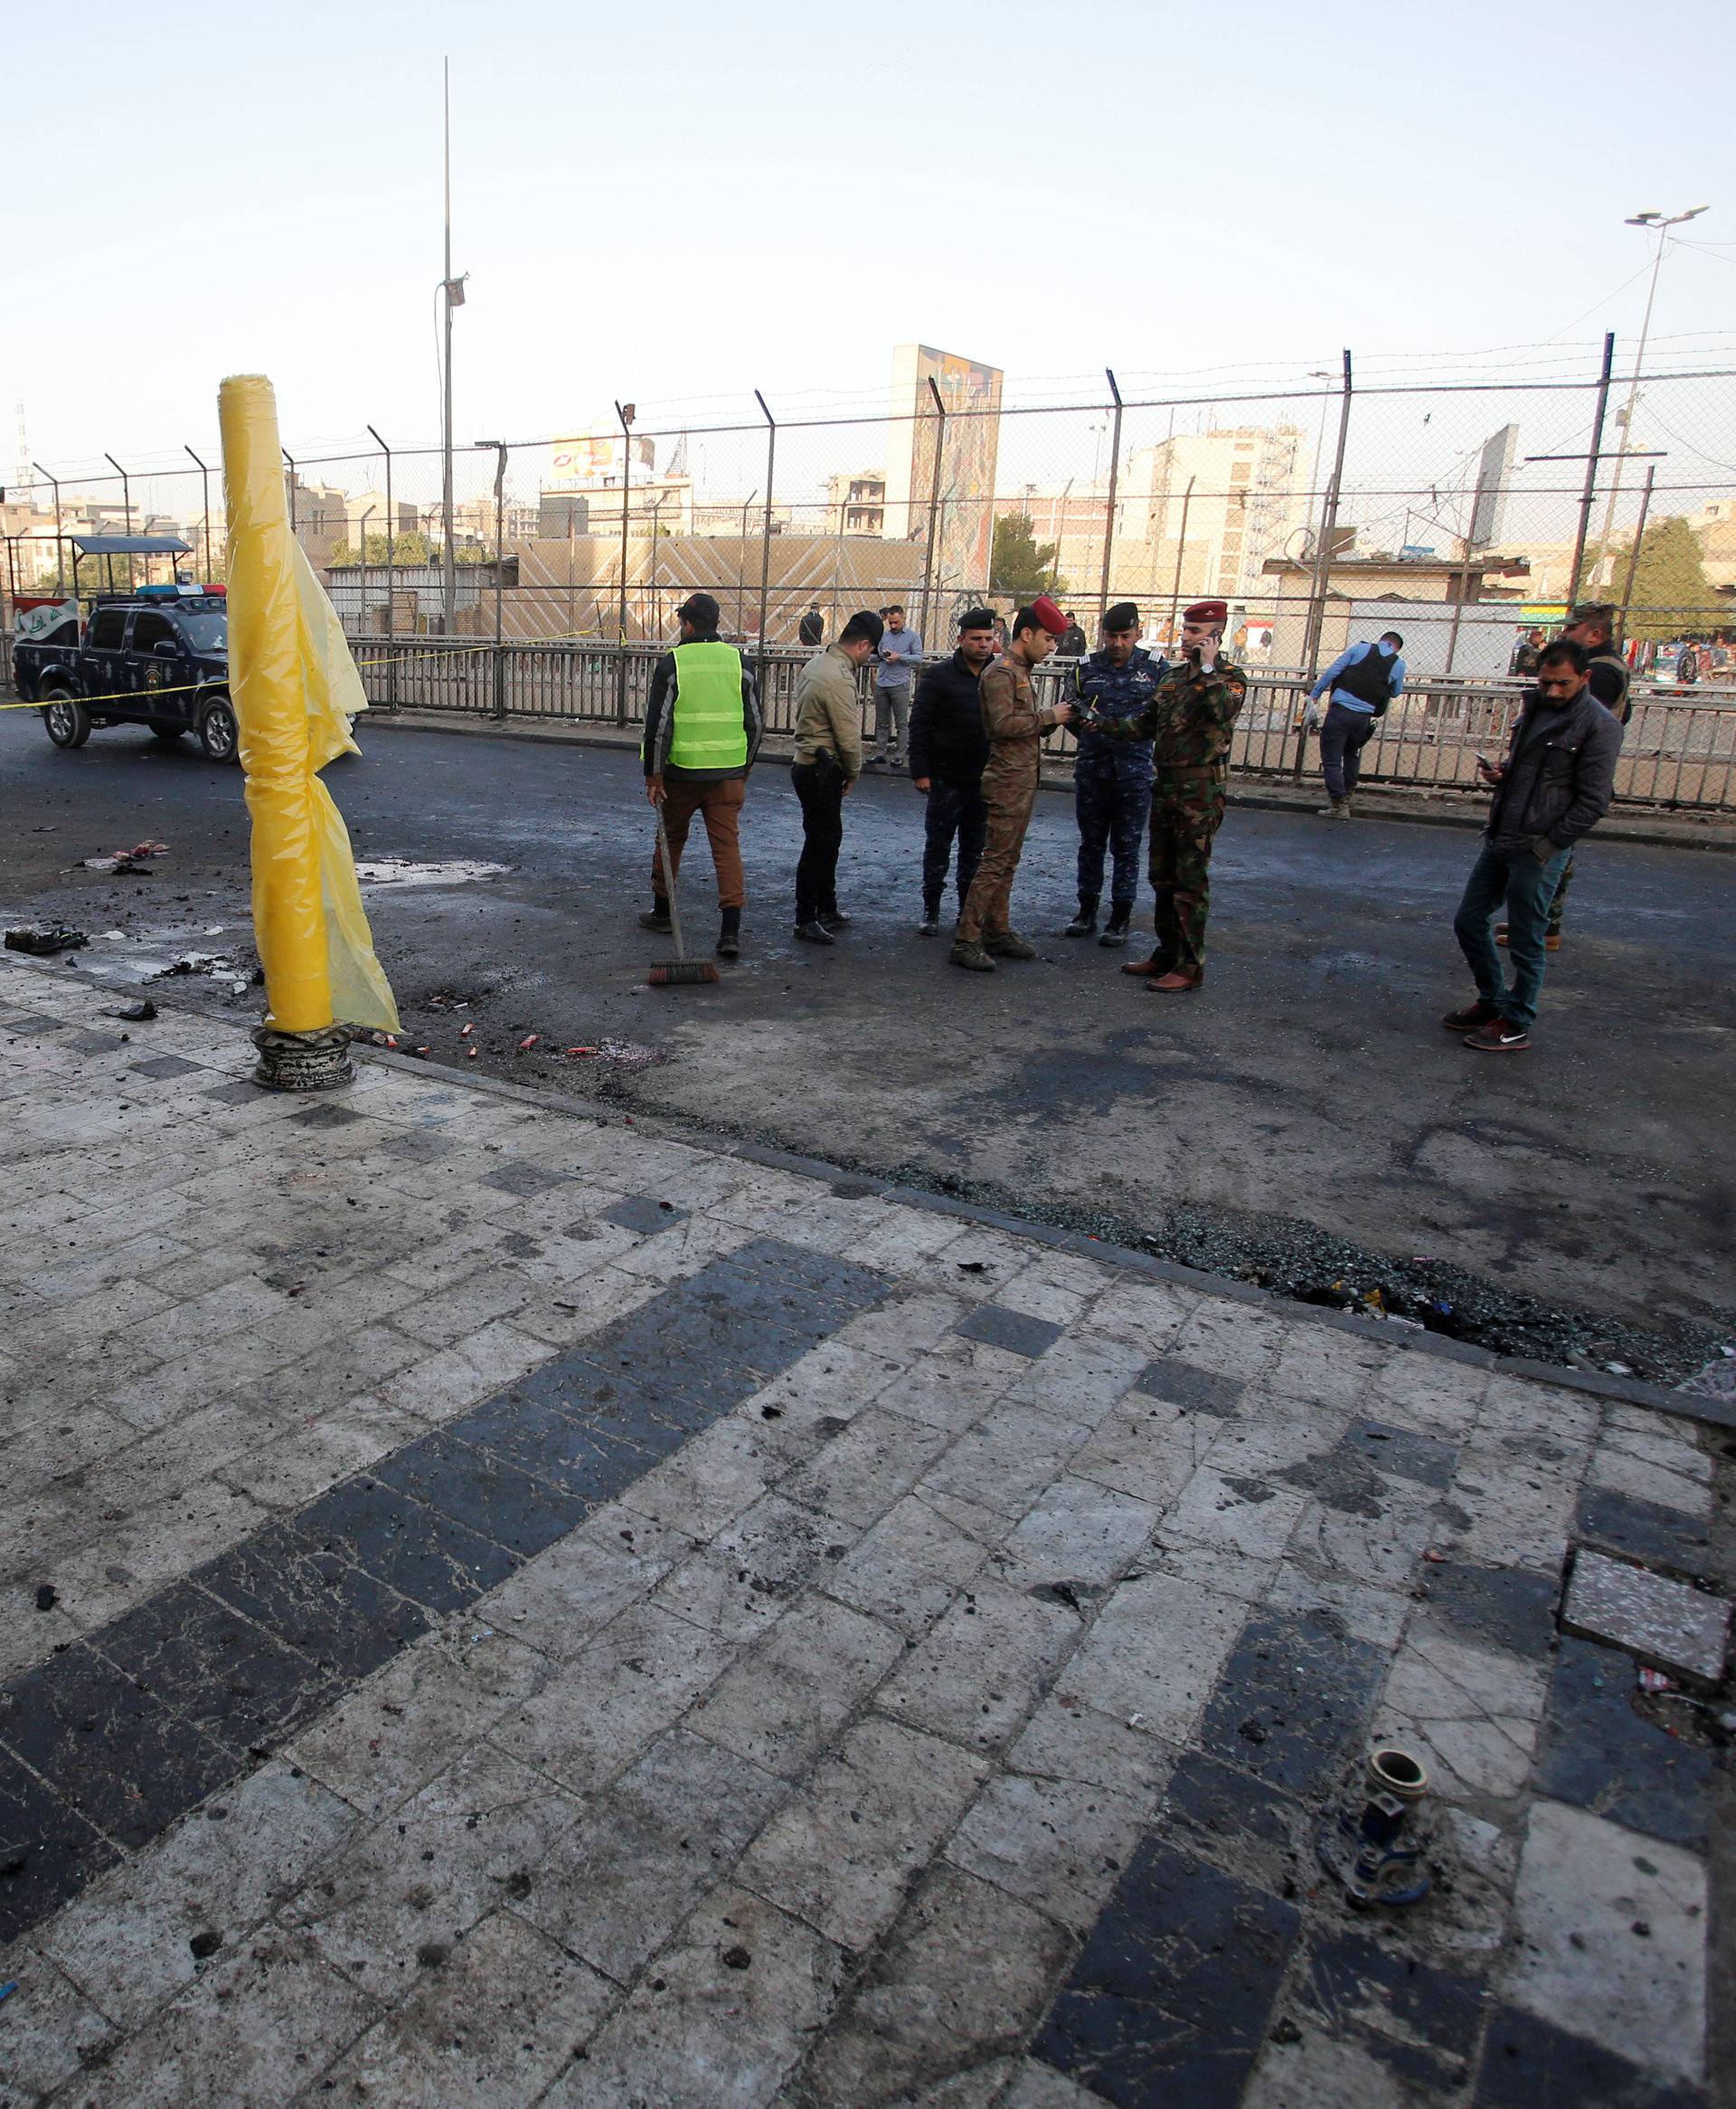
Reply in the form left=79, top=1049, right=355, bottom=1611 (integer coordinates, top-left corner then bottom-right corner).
left=1090, top=601, right=1247, bottom=996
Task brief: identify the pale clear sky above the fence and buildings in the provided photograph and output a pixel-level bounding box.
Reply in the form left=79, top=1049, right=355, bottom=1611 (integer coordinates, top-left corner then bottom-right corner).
left=0, top=0, right=1736, bottom=506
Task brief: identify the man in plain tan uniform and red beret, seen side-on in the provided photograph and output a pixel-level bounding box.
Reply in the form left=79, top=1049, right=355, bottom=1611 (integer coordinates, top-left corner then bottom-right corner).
left=947, top=592, right=1076, bottom=974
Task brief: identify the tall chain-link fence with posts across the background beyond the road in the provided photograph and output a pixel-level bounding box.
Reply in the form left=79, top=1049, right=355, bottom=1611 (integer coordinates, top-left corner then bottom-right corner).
left=0, top=339, right=1736, bottom=806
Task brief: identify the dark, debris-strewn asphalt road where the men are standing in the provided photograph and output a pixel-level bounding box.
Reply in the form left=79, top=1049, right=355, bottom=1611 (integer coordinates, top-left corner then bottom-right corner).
left=0, top=711, right=1736, bottom=1368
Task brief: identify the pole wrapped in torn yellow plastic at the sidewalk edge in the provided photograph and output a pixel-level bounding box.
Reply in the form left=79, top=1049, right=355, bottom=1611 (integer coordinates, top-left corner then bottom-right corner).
left=217, top=374, right=399, bottom=1088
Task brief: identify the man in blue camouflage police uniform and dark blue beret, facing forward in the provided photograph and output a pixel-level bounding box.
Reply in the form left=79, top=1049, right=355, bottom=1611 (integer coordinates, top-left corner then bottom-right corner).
left=1067, top=601, right=1168, bottom=945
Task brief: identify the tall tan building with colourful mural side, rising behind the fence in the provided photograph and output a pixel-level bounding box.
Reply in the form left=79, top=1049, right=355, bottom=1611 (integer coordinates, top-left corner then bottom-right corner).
left=882, top=344, right=1004, bottom=592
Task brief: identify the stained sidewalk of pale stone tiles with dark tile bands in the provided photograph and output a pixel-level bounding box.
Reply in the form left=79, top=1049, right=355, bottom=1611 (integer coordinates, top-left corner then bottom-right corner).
left=0, top=960, right=1730, bottom=2109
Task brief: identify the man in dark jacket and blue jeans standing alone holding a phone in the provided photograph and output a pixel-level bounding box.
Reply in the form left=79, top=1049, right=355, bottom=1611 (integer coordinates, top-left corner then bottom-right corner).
left=1440, top=639, right=1622, bottom=1054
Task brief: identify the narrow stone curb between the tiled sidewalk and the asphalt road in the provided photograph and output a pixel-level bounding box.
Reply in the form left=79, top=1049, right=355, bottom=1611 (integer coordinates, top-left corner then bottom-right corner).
left=353, top=1044, right=1736, bottom=1430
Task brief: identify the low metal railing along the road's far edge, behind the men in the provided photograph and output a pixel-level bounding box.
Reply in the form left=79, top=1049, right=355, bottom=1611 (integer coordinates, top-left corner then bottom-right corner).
left=354, top=637, right=1736, bottom=812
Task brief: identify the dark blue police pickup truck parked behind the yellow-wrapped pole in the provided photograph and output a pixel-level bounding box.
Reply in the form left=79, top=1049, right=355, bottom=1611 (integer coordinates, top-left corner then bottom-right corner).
left=13, top=584, right=236, bottom=761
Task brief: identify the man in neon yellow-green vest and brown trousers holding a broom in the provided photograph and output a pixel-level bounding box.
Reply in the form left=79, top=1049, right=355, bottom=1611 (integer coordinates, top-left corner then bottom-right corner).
left=639, top=592, right=766, bottom=960
